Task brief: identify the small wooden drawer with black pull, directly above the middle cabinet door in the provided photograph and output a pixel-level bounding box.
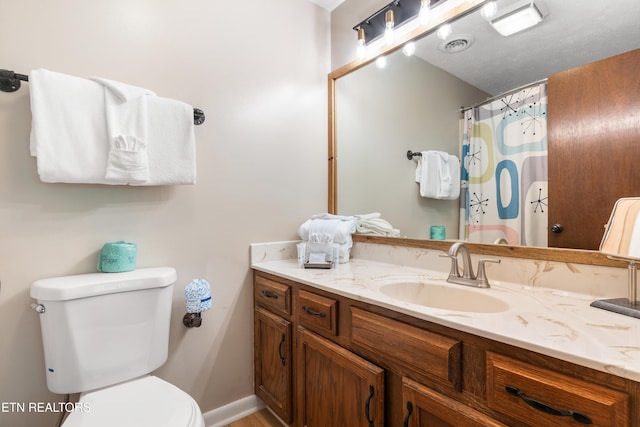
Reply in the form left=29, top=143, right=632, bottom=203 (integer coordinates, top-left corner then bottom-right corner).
left=298, top=290, right=338, bottom=335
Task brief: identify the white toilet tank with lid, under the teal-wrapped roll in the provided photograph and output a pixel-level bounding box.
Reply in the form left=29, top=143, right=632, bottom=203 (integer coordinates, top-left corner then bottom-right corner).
left=31, top=267, right=177, bottom=394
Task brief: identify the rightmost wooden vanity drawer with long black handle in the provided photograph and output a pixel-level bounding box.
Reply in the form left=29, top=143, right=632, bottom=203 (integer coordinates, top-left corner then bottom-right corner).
left=487, top=352, right=630, bottom=426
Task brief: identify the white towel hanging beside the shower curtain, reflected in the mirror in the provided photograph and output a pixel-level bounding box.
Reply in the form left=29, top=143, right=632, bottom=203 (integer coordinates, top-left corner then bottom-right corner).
left=415, top=150, right=460, bottom=200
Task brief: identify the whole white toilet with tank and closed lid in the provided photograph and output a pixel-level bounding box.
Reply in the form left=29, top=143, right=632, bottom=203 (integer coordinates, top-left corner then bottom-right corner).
left=31, top=267, right=205, bottom=427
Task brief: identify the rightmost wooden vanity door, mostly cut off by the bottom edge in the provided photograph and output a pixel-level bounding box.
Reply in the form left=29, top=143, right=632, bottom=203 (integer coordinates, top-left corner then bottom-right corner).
left=402, top=378, right=506, bottom=427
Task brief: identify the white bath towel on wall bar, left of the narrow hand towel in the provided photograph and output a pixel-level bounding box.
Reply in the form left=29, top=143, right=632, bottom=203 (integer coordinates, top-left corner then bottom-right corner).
left=29, top=69, right=109, bottom=183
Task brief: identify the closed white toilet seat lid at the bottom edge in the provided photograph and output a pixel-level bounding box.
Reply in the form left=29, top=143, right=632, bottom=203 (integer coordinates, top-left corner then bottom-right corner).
left=63, top=376, right=204, bottom=427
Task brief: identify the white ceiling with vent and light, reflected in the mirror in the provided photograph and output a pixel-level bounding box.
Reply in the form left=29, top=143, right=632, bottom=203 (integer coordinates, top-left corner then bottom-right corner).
left=412, top=0, right=640, bottom=95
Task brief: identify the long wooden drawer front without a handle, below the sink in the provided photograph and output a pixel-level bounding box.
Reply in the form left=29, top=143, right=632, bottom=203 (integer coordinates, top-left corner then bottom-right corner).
left=351, top=307, right=462, bottom=390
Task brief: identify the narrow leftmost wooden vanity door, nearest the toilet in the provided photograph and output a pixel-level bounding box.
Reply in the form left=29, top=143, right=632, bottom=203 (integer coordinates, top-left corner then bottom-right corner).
left=254, top=307, right=292, bottom=423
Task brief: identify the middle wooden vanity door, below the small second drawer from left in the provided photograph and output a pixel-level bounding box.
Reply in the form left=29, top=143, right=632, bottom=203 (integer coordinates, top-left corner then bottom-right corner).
left=296, top=328, right=384, bottom=427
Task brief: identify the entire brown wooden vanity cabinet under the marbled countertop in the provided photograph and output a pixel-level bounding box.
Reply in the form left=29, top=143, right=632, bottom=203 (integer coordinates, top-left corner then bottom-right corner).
left=254, top=272, right=640, bottom=427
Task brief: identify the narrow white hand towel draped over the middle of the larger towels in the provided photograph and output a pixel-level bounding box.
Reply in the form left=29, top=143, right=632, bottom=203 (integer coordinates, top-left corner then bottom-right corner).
left=92, top=78, right=155, bottom=184
